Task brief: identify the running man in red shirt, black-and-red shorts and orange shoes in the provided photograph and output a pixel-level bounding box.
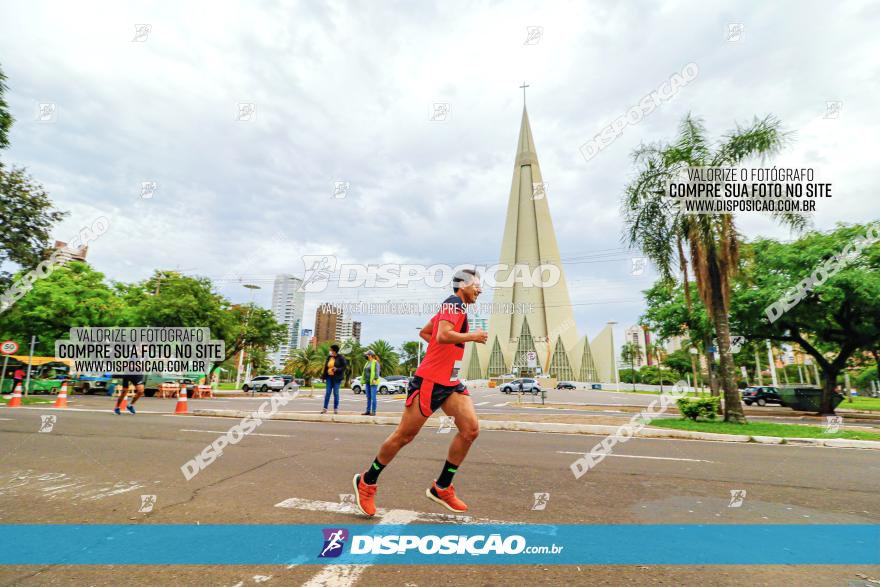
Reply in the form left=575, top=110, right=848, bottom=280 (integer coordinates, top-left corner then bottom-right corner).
left=352, top=269, right=488, bottom=516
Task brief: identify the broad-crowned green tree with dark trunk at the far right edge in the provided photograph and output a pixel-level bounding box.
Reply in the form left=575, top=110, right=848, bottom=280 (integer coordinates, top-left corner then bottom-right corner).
left=731, top=225, right=880, bottom=414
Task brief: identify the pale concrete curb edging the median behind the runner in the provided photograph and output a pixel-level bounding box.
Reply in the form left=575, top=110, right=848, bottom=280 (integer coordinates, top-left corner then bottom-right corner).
left=192, top=409, right=880, bottom=450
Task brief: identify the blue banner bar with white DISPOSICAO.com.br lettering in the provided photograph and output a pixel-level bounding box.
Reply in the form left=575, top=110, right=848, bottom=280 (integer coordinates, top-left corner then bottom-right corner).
left=0, top=524, right=880, bottom=565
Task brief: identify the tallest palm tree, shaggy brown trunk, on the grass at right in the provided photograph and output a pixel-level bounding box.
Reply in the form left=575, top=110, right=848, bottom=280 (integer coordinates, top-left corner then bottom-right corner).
left=622, top=114, right=806, bottom=423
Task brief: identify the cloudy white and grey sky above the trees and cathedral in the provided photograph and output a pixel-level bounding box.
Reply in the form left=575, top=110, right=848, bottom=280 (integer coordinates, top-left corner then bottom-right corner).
left=0, top=0, right=880, bottom=350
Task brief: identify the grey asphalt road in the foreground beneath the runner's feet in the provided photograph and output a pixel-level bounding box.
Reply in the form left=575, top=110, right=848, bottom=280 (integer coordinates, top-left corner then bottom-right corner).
left=0, top=398, right=880, bottom=587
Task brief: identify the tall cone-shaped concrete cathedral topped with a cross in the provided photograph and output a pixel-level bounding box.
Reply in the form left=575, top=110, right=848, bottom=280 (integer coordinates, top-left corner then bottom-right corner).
left=463, top=107, right=614, bottom=381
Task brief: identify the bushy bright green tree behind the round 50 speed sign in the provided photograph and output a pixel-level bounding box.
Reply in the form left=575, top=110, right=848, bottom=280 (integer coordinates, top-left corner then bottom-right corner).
left=0, top=261, right=125, bottom=357
